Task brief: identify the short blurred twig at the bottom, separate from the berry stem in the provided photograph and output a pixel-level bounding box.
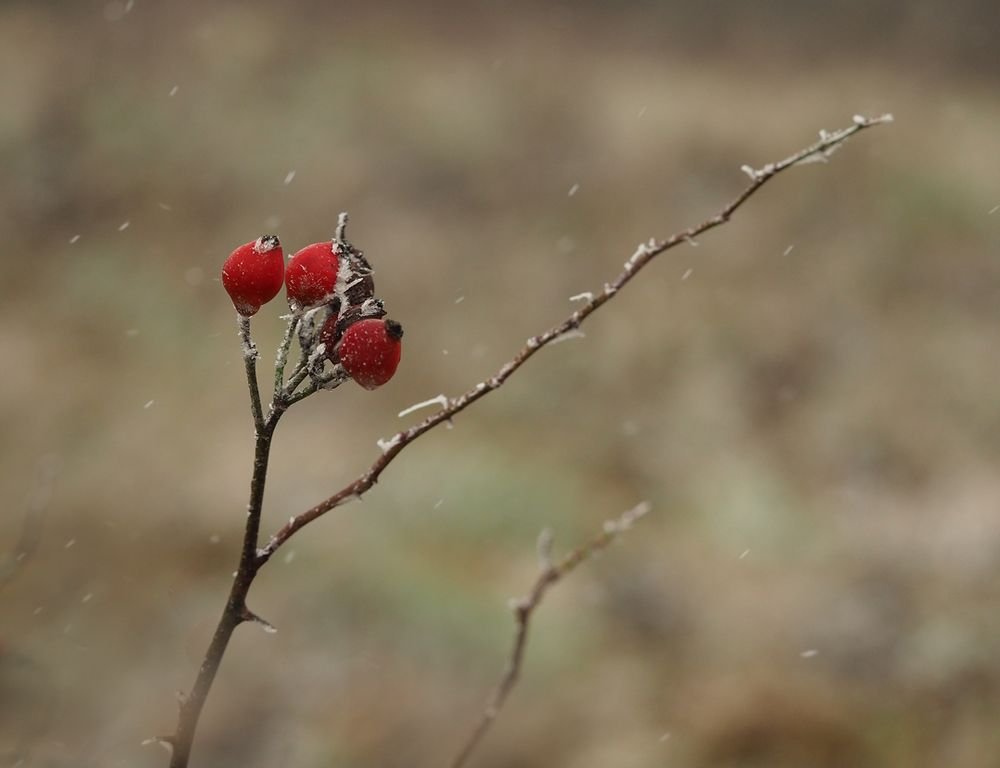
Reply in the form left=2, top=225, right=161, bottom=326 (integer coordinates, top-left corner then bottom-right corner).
left=450, top=501, right=650, bottom=768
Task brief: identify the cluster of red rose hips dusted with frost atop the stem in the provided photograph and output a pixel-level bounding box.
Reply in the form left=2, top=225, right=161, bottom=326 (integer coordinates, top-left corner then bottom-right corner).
left=222, top=227, right=403, bottom=389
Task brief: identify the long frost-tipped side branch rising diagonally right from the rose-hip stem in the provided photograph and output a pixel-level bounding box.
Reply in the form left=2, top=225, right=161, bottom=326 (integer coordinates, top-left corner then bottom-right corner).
left=258, top=115, right=892, bottom=565
